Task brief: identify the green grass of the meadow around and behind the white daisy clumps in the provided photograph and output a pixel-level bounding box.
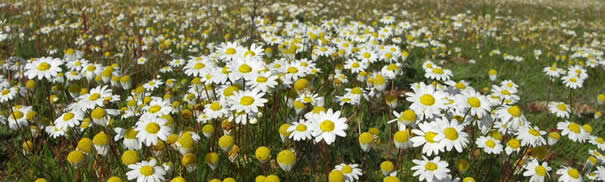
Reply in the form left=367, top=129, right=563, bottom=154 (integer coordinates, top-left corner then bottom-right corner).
left=0, top=0, right=605, bottom=181
